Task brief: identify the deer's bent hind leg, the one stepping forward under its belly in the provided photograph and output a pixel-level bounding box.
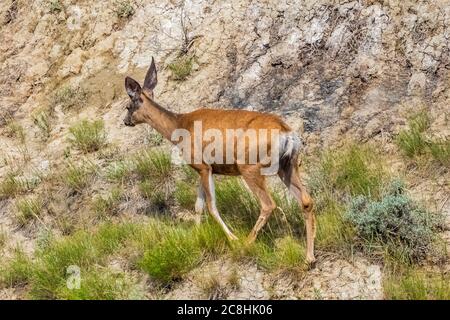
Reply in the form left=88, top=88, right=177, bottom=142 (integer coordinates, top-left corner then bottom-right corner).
left=241, top=167, right=276, bottom=243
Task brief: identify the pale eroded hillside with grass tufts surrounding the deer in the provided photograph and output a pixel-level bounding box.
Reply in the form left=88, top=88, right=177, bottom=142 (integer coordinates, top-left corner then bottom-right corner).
left=0, top=0, right=450, bottom=299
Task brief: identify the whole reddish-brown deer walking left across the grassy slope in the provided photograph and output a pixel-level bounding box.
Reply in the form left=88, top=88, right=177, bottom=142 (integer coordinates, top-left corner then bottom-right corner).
left=123, top=57, right=316, bottom=266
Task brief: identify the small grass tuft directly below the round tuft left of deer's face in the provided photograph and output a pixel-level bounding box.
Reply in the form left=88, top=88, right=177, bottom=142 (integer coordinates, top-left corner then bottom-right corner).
left=61, top=162, right=95, bottom=193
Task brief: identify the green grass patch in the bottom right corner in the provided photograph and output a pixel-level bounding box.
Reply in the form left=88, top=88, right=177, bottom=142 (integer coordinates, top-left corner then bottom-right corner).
left=384, top=269, right=450, bottom=300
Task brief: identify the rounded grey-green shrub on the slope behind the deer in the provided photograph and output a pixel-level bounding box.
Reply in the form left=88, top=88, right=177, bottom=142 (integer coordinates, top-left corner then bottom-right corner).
left=346, top=181, right=443, bottom=260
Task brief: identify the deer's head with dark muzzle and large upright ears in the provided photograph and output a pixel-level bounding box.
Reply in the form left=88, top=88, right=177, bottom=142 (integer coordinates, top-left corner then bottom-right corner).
left=123, top=57, right=158, bottom=127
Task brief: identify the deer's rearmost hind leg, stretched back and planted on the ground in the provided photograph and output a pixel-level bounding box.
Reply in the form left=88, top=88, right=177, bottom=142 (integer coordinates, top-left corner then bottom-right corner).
left=278, top=161, right=316, bottom=264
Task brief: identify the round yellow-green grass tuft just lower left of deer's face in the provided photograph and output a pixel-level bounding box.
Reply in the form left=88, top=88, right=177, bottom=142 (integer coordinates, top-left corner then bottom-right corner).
left=69, top=120, right=106, bottom=153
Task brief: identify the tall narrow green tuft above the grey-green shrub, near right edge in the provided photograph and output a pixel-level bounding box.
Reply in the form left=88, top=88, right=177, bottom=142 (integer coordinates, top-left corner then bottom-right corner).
left=396, top=111, right=430, bottom=158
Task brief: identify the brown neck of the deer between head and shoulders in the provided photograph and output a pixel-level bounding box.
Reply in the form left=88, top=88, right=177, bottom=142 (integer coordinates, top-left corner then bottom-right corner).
left=144, top=94, right=178, bottom=141
